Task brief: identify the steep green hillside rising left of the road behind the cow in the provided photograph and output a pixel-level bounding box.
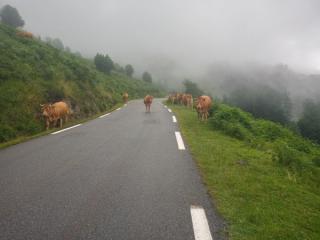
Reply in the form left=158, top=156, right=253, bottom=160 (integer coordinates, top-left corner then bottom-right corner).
left=0, top=24, right=161, bottom=143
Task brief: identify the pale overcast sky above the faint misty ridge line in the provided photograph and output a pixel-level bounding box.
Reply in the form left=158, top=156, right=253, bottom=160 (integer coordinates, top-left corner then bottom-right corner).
left=0, top=0, right=320, bottom=77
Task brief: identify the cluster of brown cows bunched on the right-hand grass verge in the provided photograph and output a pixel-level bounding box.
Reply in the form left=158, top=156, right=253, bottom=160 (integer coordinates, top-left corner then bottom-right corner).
left=168, top=93, right=212, bottom=120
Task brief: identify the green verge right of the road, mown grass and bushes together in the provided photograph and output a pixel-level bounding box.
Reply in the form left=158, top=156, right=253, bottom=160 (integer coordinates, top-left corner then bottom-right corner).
left=171, top=104, right=320, bottom=240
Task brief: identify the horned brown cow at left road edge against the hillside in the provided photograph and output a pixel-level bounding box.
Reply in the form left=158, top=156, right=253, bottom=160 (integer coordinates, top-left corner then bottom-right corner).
left=41, top=102, right=70, bottom=130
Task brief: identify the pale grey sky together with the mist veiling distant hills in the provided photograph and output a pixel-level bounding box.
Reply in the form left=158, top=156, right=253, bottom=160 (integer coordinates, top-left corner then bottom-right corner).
left=0, top=0, right=320, bottom=128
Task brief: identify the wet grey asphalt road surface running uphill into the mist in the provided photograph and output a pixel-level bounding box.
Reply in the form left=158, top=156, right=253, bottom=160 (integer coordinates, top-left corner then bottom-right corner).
left=0, top=100, right=223, bottom=240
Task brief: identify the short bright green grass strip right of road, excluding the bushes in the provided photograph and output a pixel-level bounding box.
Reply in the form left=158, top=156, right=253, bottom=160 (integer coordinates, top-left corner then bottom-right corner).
left=172, top=106, right=320, bottom=240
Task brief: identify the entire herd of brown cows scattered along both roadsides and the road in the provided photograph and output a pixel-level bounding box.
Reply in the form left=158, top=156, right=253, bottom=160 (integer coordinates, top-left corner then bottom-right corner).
left=40, top=92, right=212, bottom=130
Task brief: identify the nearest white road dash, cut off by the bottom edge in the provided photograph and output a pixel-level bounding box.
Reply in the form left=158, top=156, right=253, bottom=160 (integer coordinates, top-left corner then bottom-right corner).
left=190, top=205, right=213, bottom=240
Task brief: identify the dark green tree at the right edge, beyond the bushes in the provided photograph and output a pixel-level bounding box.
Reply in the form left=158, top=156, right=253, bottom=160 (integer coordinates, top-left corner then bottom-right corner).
left=298, top=100, right=320, bottom=143
